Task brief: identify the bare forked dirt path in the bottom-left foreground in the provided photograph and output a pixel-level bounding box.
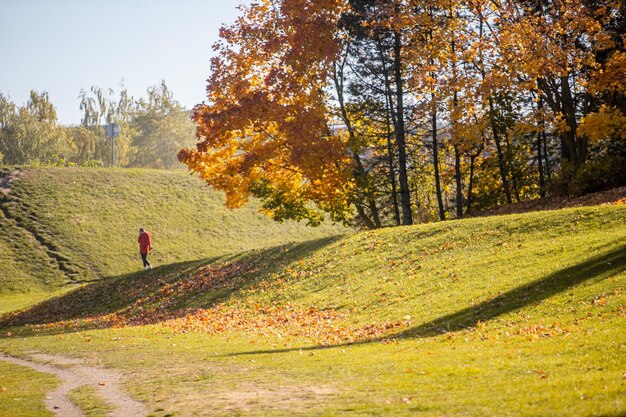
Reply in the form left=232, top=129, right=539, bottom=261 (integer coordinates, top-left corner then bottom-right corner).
left=0, top=353, right=148, bottom=417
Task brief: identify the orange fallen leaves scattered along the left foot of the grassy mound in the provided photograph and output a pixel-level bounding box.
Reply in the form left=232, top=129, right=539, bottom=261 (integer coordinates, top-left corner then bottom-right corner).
left=0, top=257, right=411, bottom=345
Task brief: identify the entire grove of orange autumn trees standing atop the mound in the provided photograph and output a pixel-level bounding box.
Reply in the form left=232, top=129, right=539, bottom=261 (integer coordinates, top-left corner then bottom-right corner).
left=179, top=0, right=626, bottom=228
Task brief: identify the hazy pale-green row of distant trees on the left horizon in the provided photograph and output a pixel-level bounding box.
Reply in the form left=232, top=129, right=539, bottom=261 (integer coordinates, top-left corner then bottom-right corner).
left=0, top=82, right=195, bottom=168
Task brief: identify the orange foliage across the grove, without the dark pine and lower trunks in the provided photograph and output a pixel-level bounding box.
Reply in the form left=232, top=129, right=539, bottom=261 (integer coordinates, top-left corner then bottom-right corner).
left=179, top=0, right=626, bottom=224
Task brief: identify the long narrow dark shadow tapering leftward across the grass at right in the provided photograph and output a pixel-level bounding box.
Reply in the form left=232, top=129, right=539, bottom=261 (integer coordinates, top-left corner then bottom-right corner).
left=226, top=245, right=626, bottom=356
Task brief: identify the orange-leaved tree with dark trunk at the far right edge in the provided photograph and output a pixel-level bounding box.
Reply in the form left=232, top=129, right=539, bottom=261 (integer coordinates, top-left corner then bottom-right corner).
left=498, top=0, right=626, bottom=187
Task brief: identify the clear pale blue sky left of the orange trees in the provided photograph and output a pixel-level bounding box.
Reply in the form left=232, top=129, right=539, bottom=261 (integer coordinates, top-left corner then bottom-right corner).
left=0, top=0, right=248, bottom=124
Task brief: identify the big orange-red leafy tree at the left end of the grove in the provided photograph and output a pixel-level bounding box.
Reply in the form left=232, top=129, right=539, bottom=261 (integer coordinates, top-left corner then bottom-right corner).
left=179, top=0, right=359, bottom=224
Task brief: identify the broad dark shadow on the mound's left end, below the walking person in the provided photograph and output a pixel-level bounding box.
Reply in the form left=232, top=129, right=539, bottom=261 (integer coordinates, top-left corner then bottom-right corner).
left=0, top=236, right=341, bottom=338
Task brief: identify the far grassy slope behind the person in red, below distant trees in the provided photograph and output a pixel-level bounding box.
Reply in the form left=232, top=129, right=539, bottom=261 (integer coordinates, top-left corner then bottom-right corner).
left=0, top=168, right=343, bottom=293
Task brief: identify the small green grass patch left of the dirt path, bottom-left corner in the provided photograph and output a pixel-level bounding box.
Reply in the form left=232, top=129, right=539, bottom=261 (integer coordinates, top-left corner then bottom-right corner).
left=0, top=361, right=58, bottom=417
